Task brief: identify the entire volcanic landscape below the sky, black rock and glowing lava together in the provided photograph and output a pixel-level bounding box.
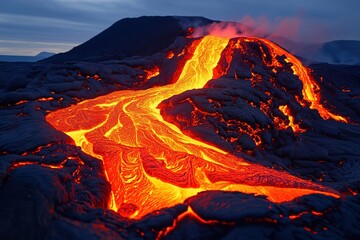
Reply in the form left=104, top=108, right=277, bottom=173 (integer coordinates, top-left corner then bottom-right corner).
left=0, top=17, right=360, bottom=239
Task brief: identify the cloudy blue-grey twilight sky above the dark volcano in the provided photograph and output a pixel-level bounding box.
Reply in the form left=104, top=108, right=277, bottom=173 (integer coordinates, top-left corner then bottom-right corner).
left=0, top=0, right=360, bottom=55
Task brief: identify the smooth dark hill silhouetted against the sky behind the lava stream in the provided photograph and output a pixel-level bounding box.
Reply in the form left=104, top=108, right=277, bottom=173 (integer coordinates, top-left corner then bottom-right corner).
left=45, top=17, right=214, bottom=63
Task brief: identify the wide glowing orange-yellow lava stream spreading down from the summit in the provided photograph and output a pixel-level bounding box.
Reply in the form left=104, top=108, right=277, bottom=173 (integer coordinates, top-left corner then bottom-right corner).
left=46, top=36, right=338, bottom=218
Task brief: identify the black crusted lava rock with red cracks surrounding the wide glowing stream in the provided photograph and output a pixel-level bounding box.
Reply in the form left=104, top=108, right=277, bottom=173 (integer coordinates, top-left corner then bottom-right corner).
left=0, top=15, right=360, bottom=239
